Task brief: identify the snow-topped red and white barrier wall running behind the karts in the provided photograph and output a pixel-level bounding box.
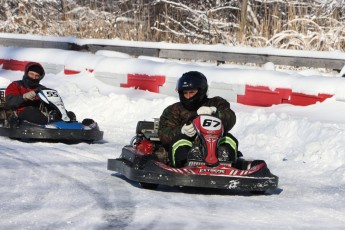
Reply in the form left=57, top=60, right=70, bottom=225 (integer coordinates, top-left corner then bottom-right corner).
left=0, top=59, right=333, bottom=106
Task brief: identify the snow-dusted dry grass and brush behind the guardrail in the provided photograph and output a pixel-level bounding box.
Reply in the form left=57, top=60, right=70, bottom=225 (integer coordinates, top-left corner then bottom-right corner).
left=0, top=0, right=345, bottom=51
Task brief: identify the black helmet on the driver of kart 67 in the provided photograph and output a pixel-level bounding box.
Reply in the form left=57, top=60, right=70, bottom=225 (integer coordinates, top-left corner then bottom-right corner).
left=177, top=71, right=208, bottom=110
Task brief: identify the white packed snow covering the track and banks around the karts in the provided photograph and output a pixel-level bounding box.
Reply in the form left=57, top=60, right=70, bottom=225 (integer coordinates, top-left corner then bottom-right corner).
left=0, top=42, right=345, bottom=230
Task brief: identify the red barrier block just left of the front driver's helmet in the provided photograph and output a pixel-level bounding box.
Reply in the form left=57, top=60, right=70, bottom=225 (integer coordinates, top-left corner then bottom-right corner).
left=120, top=74, right=165, bottom=93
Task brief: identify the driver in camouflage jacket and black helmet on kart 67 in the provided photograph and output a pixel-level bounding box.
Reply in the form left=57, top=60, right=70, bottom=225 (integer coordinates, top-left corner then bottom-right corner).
left=158, top=71, right=238, bottom=168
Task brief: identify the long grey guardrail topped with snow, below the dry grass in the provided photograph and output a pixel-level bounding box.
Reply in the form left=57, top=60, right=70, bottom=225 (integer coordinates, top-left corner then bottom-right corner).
left=0, top=37, right=345, bottom=71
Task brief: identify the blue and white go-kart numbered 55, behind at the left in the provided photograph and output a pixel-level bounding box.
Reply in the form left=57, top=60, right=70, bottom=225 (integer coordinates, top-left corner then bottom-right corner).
left=0, top=89, right=103, bottom=143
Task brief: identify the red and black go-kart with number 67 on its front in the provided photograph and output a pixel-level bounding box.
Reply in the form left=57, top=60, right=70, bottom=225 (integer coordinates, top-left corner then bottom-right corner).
left=108, top=115, right=278, bottom=193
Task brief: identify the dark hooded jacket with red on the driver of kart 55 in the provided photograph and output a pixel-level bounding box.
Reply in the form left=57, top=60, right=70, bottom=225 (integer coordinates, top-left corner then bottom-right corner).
left=5, top=62, right=46, bottom=114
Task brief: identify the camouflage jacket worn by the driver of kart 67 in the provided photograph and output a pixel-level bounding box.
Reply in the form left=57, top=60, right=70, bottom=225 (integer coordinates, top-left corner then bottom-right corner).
left=158, top=97, right=236, bottom=146
